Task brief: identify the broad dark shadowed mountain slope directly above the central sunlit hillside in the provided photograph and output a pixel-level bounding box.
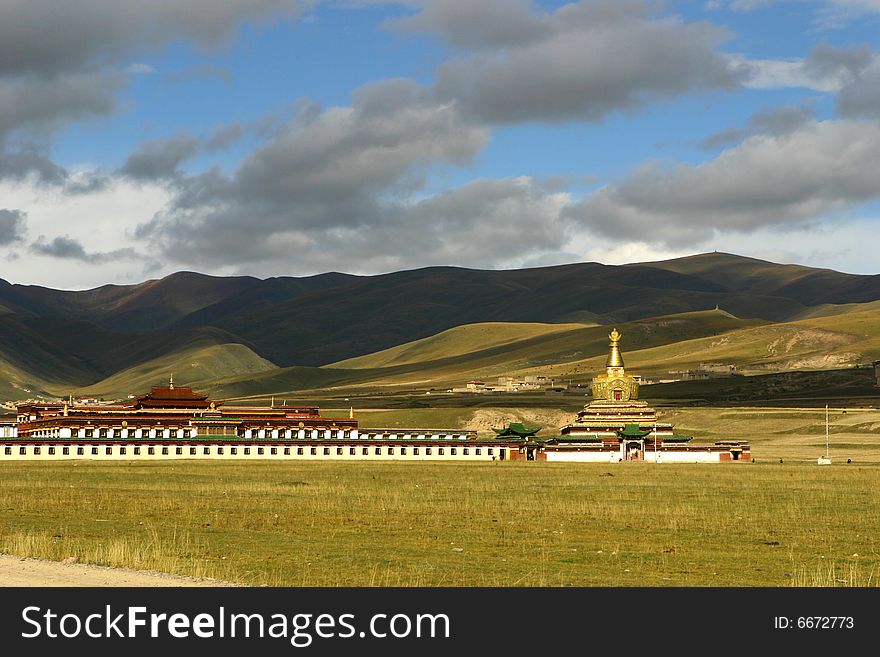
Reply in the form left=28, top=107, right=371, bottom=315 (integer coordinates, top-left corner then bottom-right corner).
left=218, top=256, right=860, bottom=366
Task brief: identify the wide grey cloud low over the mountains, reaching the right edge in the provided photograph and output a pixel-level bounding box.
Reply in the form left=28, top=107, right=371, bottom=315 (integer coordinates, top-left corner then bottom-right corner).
left=566, top=121, right=880, bottom=246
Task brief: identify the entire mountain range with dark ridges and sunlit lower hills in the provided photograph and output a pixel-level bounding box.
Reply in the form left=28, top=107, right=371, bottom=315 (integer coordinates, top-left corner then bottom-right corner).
left=0, top=253, right=880, bottom=399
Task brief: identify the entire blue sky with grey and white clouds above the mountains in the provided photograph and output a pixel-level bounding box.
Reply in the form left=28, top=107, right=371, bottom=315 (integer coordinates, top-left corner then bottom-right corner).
left=0, top=0, right=880, bottom=289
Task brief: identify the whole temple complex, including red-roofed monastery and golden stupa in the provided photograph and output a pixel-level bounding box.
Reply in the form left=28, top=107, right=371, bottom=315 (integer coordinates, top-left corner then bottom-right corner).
left=0, top=329, right=751, bottom=463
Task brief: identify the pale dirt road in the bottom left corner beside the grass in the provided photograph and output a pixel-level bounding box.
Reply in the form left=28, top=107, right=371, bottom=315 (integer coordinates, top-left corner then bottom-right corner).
left=0, top=555, right=233, bottom=587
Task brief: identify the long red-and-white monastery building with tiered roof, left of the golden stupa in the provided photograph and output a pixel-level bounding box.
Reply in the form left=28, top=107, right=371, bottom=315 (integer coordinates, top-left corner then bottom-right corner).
left=0, top=378, right=514, bottom=460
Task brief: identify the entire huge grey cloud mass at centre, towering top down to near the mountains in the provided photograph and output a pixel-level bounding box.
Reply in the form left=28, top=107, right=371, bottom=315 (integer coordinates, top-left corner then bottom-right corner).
left=137, top=80, right=572, bottom=268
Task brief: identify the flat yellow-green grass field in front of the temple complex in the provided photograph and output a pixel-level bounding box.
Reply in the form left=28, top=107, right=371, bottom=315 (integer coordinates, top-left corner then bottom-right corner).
left=0, top=461, right=880, bottom=586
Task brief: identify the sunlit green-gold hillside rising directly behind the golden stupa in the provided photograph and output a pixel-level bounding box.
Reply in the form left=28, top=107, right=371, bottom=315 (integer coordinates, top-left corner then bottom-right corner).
left=199, top=304, right=880, bottom=397
